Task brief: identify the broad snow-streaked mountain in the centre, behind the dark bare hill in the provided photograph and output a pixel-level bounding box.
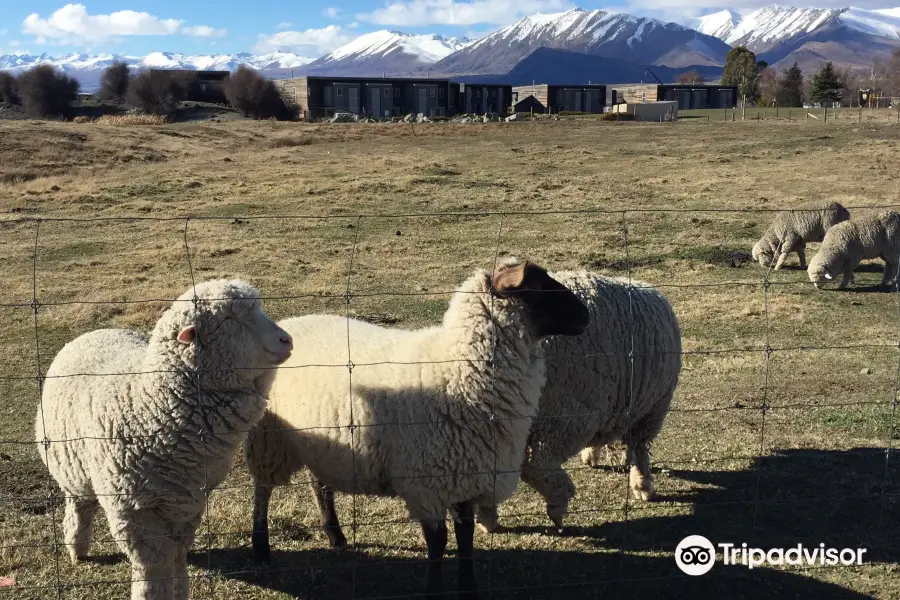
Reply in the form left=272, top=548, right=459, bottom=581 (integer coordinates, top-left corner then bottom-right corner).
left=434, top=8, right=729, bottom=74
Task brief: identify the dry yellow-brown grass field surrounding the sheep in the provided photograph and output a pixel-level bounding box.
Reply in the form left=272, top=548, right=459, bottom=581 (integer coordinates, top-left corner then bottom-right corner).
left=0, top=117, right=900, bottom=600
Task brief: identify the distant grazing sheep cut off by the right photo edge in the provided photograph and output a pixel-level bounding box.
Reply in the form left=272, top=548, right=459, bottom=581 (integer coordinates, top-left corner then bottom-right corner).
left=807, top=210, right=900, bottom=289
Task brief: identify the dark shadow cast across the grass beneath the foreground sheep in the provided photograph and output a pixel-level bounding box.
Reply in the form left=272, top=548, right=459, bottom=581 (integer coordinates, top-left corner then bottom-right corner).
left=191, top=448, right=900, bottom=600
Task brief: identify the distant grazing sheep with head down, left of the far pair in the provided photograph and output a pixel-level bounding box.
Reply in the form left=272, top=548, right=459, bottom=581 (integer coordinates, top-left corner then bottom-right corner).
left=751, top=202, right=850, bottom=271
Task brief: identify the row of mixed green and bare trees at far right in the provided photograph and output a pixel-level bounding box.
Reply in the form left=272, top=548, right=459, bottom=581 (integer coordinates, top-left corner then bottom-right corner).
left=722, top=46, right=900, bottom=107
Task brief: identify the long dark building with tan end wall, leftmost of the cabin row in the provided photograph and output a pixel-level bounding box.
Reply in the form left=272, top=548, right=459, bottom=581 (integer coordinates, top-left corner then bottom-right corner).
left=275, top=76, right=458, bottom=120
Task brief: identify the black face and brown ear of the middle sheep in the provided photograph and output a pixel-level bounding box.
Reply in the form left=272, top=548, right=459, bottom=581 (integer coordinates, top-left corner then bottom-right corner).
left=492, top=261, right=590, bottom=339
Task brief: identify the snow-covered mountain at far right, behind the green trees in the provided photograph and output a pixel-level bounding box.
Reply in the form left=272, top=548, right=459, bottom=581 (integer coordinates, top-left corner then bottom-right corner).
left=695, top=5, right=900, bottom=68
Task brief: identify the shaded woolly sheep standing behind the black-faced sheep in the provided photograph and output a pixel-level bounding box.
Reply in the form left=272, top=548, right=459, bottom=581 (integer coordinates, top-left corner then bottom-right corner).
left=477, top=271, right=681, bottom=531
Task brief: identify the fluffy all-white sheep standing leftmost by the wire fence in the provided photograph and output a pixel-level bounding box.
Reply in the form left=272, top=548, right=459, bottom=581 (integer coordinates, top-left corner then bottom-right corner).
left=35, top=280, right=292, bottom=600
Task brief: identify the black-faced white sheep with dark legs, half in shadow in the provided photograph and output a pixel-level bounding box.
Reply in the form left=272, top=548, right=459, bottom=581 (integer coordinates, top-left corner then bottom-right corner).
left=246, top=261, right=589, bottom=595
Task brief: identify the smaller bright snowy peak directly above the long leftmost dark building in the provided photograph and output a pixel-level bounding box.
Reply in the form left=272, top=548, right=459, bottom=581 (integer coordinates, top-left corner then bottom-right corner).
left=304, top=30, right=472, bottom=75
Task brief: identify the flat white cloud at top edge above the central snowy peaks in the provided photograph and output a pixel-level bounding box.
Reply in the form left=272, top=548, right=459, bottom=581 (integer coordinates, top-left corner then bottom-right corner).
left=356, top=0, right=568, bottom=27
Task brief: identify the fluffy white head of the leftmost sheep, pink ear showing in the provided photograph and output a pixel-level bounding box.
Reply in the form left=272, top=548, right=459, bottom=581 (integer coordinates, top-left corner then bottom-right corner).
left=169, top=281, right=294, bottom=379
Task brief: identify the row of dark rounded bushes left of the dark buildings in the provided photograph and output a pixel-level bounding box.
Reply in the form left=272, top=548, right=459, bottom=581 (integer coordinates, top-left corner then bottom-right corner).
left=0, top=61, right=295, bottom=119
